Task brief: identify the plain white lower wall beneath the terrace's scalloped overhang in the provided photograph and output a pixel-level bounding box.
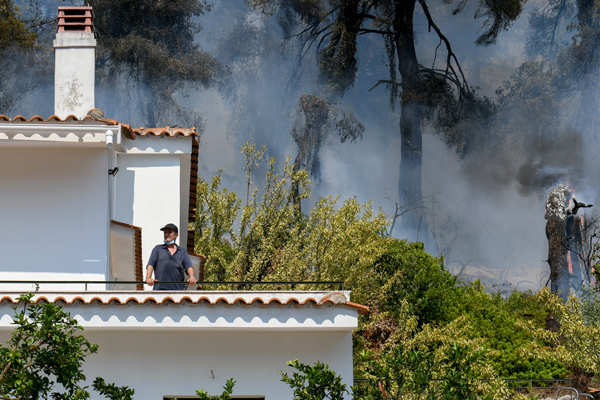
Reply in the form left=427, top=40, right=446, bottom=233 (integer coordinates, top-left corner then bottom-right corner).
left=86, top=331, right=352, bottom=400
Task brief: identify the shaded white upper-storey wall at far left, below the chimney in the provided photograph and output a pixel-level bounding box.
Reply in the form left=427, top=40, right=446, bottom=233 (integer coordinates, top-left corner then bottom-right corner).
left=0, top=147, right=108, bottom=290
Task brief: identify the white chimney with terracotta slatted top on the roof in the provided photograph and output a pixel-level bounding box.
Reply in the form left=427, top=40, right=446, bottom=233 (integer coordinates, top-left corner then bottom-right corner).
left=54, top=6, right=96, bottom=119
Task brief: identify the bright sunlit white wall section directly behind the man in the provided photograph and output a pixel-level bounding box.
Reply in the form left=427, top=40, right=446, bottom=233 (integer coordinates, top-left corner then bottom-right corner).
left=115, top=154, right=182, bottom=284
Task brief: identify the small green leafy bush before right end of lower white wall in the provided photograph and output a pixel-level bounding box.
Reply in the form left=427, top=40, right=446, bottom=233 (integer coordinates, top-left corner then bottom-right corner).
left=281, top=360, right=348, bottom=400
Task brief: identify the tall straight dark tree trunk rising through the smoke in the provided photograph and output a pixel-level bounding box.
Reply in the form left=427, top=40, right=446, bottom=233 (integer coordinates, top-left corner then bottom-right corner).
left=393, top=0, right=427, bottom=240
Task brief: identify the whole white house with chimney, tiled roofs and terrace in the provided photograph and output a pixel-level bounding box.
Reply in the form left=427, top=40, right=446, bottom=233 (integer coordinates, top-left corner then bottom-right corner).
left=0, top=7, right=367, bottom=400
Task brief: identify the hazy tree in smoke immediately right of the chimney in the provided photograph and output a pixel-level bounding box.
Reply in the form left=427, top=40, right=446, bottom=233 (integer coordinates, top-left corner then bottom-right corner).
left=86, top=0, right=224, bottom=126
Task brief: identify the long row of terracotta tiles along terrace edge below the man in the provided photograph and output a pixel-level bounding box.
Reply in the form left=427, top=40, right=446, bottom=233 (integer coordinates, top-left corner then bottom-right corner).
left=0, top=292, right=369, bottom=314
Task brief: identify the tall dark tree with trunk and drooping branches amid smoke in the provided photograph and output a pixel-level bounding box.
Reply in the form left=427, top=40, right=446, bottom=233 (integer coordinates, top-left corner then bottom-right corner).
left=248, top=0, right=523, bottom=238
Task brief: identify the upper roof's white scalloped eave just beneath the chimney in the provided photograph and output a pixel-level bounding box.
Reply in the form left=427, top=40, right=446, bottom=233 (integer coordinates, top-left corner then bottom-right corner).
left=0, top=122, right=122, bottom=147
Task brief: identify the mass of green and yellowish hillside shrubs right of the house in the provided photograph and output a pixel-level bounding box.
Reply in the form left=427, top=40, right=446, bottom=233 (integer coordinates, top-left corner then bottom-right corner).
left=194, top=143, right=600, bottom=399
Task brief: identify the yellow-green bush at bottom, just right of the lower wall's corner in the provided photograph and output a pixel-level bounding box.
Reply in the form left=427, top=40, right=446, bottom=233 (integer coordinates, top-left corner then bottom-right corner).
left=354, top=301, right=508, bottom=400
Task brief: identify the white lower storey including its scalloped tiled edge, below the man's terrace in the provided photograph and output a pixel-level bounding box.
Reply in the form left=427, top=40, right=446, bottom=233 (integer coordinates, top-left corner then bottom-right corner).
left=0, top=291, right=358, bottom=400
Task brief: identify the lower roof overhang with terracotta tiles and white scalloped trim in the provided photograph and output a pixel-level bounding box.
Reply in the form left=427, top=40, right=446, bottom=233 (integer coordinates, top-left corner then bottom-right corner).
left=0, top=291, right=368, bottom=331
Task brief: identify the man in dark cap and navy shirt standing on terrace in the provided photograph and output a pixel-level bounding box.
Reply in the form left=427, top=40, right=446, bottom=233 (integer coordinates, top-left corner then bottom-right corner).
left=146, top=224, right=196, bottom=290
